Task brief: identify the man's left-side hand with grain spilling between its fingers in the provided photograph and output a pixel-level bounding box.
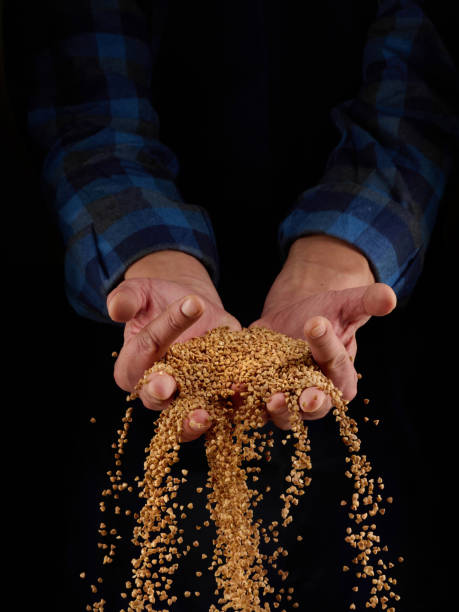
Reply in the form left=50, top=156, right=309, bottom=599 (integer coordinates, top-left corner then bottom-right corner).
left=107, top=251, right=241, bottom=442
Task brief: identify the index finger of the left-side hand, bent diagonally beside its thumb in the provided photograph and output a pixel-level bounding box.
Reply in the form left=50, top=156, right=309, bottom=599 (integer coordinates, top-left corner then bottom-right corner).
left=114, top=295, right=204, bottom=391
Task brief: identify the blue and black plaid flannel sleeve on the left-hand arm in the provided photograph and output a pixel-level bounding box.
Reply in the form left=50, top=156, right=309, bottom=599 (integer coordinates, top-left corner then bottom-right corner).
left=28, top=0, right=218, bottom=321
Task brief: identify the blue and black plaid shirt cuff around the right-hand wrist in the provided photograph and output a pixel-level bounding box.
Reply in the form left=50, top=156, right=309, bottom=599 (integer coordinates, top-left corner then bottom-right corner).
left=278, top=182, right=423, bottom=299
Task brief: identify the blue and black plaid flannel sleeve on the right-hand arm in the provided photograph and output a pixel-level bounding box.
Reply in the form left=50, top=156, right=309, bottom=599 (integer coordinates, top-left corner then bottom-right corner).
left=278, top=0, right=459, bottom=298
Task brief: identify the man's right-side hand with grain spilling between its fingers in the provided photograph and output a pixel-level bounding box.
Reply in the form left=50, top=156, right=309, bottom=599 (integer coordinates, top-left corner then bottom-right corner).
left=250, top=236, right=396, bottom=429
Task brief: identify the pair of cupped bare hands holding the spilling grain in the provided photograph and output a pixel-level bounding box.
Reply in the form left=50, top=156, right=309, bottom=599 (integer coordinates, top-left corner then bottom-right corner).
left=107, top=235, right=396, bottom=442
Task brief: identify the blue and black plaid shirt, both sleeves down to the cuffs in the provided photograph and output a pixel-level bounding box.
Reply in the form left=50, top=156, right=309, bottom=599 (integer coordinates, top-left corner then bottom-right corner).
left=28, top=0, right=459, bottom=320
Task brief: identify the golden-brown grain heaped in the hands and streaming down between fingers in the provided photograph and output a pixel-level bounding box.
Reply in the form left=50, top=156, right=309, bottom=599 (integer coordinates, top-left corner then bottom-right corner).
left=87, top=327, right=399, bottom=612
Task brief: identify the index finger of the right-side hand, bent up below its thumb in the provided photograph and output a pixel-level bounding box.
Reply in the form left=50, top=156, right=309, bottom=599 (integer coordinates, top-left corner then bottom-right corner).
left=304, top=316, right=357, bottom=400
